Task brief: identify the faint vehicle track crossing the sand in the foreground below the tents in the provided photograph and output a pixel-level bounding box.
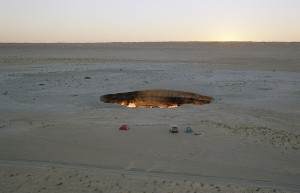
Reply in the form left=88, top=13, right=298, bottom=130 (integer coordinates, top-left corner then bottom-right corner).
left=0, top=160, right=300, bottom=192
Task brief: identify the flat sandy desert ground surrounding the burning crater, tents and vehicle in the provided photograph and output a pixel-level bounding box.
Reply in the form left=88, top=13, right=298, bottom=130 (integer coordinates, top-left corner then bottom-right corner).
left=0, top=43, right=300, bottom=193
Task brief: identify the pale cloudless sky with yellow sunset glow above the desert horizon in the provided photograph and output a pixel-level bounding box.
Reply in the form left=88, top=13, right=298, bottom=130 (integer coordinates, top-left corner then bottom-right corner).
left=0, top=0, right=300, bottom=42
